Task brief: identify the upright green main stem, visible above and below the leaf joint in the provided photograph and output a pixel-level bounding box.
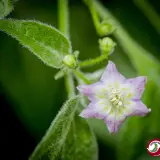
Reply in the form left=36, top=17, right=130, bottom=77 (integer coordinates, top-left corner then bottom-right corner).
left=58, top=0, right=75, bottom=98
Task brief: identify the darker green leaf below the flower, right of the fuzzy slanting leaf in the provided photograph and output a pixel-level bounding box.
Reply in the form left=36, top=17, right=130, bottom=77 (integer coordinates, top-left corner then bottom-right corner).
left=61, top=113, right=98, bottom=160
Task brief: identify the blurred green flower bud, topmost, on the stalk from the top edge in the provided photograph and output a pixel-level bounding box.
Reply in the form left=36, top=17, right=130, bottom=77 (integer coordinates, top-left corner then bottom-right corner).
left=98, top=21, right=115, bottom=36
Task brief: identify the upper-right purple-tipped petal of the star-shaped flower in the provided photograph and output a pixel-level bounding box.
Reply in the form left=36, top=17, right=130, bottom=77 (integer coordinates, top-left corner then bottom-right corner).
left=127, top=76, right=147, bottom=99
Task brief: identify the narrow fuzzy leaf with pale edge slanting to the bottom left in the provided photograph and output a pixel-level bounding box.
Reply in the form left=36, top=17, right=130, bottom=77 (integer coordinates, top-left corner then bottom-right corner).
left=30, top=97, right=78, bottom=160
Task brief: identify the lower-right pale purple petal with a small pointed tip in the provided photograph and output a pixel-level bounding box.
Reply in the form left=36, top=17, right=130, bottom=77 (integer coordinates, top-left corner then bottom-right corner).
left=127, top=101, right=151, bottom=116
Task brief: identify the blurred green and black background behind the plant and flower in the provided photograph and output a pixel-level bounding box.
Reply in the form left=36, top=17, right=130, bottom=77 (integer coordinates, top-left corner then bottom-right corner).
left=0, top=0, right=160, bottom=160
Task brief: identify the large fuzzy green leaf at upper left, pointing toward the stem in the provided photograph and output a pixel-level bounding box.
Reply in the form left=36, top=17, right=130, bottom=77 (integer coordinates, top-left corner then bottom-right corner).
left=0, top=19, right=71, bottom=68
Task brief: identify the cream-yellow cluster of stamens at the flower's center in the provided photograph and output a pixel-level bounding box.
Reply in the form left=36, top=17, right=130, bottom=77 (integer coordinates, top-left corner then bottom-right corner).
left=109, top=89, right=123, bottom=109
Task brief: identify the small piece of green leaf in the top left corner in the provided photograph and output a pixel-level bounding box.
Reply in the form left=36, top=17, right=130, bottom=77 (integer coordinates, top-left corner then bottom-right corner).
left=0, top=0, right=13, bottom=18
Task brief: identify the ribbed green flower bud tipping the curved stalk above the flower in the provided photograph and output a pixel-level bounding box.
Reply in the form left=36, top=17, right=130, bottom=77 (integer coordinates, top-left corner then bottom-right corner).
left=99, top=37, right=116, bottom=54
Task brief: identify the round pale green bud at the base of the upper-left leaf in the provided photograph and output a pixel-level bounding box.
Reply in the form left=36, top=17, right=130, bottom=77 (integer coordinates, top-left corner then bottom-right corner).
left=63, top=54, right=77, bottom=68
